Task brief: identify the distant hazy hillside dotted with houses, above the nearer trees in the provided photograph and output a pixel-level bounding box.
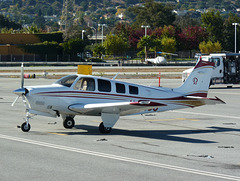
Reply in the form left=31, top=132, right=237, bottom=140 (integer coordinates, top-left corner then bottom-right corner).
left=0, top=0, right=240, bottom=31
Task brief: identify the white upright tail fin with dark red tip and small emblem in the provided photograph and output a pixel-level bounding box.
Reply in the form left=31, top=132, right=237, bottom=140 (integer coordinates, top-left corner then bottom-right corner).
left=174, top=57, right=214, bottom=97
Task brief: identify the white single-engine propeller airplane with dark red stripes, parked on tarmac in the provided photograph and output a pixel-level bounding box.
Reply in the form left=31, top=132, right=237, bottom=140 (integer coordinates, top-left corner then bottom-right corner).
left=12, top=60, right=224, bottom=133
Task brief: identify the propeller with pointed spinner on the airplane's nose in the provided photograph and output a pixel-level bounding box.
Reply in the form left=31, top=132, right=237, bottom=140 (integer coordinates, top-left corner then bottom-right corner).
left=12, top=63, right=30, bottom=107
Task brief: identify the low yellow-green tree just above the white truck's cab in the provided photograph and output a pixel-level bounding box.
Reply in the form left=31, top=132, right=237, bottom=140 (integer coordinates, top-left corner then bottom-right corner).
left=199, top=40, right=222, bottom=54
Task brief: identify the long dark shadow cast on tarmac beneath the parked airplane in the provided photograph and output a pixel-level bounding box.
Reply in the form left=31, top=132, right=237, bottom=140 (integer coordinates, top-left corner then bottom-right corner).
left=54, top=125, right=240, bottom=143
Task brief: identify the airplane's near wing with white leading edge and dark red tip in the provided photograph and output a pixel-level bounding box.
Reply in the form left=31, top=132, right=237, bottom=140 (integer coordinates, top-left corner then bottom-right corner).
left=68, top=100, right=166, bottom=115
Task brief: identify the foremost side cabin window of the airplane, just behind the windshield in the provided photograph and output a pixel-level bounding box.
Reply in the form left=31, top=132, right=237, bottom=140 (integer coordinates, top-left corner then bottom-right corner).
left=74, top=77, right=95, bottom=91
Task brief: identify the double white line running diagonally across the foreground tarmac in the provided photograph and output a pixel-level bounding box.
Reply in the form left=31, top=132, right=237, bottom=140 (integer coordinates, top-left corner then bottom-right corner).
left=0, top=134, right=240, bottom=181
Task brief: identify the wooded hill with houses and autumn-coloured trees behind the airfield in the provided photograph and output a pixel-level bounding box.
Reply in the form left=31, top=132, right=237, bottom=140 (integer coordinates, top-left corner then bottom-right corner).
left=0, top=0, right=240, bottom=60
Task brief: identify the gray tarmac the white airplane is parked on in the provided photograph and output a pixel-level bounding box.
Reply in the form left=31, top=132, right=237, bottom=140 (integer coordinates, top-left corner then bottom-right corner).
left=0, top=78, right=240, bottom=181
